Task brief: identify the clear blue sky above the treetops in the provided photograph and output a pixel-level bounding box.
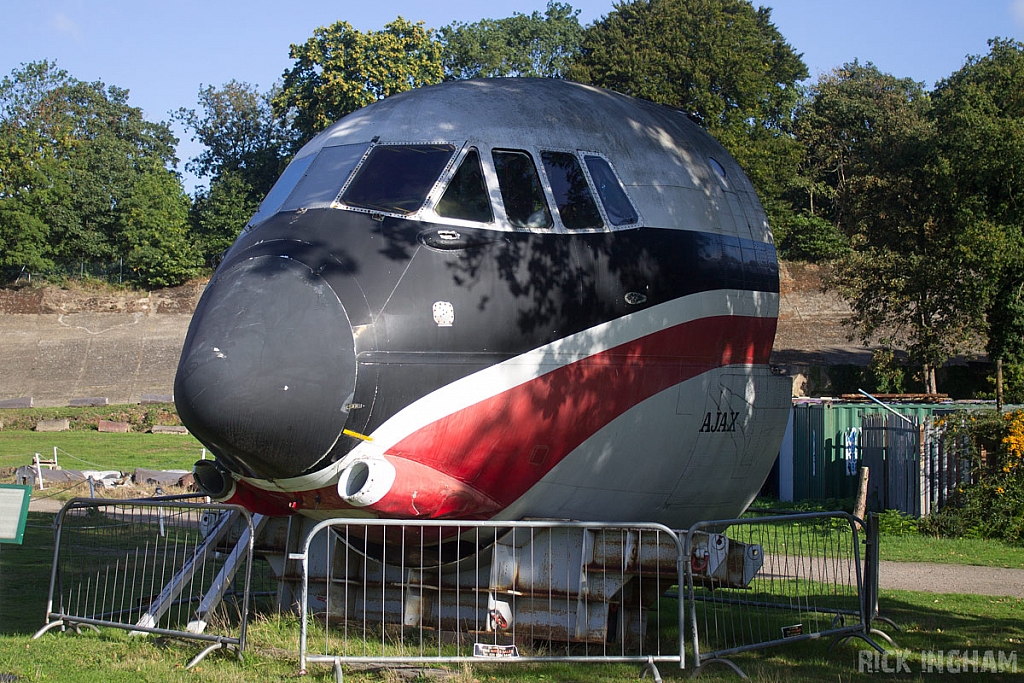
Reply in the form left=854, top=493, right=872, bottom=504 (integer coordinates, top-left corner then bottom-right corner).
left=0, top=0, right=1024, bottom=188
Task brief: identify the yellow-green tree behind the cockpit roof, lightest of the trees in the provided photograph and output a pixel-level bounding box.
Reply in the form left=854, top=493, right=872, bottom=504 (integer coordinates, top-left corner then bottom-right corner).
left=272, top=16, right=444, bottom=145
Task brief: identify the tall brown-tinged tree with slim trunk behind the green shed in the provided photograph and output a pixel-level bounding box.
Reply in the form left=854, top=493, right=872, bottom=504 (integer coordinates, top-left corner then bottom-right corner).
left=796, top=62, right=998, bottom=392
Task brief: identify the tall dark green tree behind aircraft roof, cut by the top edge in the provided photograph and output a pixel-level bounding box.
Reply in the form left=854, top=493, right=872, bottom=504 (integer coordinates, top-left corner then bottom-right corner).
left=568, top=0, right=807, bottom=232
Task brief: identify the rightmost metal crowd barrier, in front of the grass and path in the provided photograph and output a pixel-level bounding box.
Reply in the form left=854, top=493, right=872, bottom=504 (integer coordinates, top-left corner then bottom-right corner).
left=681, top=512, right=884, bottom=675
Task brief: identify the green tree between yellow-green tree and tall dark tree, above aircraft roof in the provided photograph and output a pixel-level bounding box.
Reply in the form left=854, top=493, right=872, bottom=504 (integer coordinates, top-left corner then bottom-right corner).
left=438, top=0, right=583, bottom=80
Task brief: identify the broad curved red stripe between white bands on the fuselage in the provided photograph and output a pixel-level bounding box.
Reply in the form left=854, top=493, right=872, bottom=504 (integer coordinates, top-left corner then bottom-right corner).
left=387, top=315, right=776, bottom=507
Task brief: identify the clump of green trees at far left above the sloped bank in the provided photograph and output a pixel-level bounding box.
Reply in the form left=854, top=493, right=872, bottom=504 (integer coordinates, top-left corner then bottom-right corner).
left=0, top=61, right=190, bottom=284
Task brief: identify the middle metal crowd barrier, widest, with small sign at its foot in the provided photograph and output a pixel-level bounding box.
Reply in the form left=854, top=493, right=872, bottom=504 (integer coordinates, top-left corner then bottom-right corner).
left=291, top=519, right=684, bottom=681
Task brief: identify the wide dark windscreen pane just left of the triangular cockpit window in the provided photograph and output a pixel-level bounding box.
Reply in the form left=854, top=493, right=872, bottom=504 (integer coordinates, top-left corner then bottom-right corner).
left=338, top=144, right=455, bottom=214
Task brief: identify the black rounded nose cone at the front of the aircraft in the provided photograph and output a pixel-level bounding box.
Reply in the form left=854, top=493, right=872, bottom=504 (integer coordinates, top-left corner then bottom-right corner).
left=174, top=256, right=356, bottom=479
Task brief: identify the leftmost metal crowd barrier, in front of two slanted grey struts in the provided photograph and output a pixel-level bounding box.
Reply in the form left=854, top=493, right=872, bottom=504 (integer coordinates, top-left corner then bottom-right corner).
left=33, top=497, right=261, bottom=668
